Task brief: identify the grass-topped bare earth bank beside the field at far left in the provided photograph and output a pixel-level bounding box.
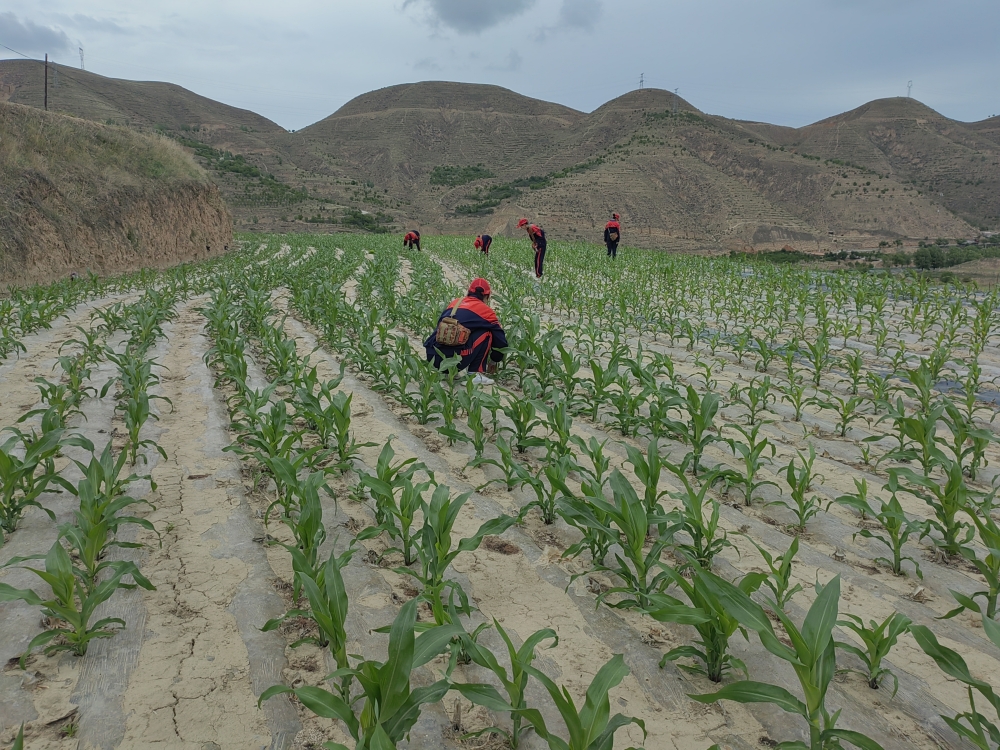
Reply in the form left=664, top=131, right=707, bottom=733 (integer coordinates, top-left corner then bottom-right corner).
left=0, top=103, right=232, bottom=285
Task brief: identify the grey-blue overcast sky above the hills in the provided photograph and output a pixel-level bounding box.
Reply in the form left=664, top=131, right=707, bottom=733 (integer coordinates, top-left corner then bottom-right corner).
left=0, top=0, right=1000, bottom=129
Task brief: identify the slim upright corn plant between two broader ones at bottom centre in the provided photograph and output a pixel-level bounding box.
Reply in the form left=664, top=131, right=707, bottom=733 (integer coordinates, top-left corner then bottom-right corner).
left=452, top=618, right=559, bottom=750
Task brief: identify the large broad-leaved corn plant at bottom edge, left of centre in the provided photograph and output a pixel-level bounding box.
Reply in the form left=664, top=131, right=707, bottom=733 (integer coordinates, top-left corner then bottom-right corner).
left=258, top=599, right=463, bottom=750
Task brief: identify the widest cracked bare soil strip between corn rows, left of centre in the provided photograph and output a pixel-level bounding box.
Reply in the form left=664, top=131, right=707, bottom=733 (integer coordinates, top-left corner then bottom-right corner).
left=118, top=302, right=297, bottom=750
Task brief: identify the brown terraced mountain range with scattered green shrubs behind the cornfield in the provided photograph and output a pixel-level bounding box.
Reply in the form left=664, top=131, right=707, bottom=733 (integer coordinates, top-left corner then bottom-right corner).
left=0, top=61, right=1000, bottom=250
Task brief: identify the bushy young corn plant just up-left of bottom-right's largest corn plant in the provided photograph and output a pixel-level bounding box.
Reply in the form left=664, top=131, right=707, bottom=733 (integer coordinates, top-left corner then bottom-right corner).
left=645, top=567, right=762, bottom=682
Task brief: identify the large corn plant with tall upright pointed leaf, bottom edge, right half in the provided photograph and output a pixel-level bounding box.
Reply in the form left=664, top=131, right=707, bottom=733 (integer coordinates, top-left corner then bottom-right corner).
left=691, top=576, right=882, bottom=750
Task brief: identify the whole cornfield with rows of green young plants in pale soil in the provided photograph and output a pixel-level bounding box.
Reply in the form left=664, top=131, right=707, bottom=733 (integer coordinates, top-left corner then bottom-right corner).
left=0, top=235, right=1000, bottom=750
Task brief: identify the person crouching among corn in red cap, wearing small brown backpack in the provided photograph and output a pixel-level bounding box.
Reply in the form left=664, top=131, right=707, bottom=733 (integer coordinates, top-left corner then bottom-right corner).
left=424, top=279, right=507, bottom=385
